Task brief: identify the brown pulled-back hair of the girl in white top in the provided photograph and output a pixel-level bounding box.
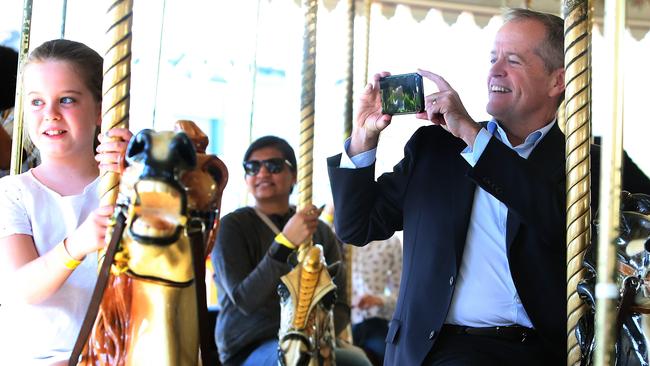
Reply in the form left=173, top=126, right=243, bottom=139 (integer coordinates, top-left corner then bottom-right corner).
left=27, top=39, right=104, bottom=102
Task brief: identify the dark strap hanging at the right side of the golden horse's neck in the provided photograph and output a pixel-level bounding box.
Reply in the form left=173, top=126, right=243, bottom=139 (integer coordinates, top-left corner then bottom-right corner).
left=186, top=220, right=217, bottom=365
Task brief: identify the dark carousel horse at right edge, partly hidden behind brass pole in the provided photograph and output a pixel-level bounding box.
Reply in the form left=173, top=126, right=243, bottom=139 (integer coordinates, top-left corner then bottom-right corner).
left=576, top=192, right=650, bottom=366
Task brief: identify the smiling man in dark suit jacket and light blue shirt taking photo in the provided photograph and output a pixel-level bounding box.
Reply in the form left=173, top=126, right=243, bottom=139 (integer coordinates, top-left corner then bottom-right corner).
left=328, top=9, right=650, bottom=365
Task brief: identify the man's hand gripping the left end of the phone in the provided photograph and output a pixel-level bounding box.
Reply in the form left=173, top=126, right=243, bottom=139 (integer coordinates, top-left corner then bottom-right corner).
left=348, top=71, right=391, bottom=156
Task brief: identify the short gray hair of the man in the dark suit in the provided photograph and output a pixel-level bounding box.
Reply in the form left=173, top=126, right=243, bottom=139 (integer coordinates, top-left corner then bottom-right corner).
left=503, top=8, right=564, bottom=72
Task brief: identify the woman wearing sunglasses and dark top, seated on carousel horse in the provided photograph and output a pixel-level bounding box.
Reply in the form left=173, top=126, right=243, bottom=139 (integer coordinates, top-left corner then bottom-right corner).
left=212, top=136, right=370, bottom=365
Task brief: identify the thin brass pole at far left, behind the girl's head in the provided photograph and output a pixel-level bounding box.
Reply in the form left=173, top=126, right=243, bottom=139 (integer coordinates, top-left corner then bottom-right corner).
left=9, top=0, right=32, bottom=175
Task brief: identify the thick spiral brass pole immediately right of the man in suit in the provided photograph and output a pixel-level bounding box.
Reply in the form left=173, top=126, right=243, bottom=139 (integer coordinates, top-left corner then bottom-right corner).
left=560, top=0, right=592, bottom=365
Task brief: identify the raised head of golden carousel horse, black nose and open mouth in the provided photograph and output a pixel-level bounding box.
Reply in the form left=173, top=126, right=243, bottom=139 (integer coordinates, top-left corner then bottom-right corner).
left=118, top=130, right=196, bottom=285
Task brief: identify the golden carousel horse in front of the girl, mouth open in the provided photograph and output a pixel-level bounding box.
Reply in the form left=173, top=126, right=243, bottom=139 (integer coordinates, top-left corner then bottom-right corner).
left=70, top=121, right=228, bottom=366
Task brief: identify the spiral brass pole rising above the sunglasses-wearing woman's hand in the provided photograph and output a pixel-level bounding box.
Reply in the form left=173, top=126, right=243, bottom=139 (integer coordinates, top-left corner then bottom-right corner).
left=298, top=0, right=318, bottom=226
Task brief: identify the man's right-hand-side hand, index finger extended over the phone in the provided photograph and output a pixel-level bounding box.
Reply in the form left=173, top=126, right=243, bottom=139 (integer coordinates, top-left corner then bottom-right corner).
left=415, top=69, right=481, bottom=146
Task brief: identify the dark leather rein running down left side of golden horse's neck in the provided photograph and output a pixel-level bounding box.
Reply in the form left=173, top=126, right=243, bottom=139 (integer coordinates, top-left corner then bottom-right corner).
left=68, top=210, right=126, bottom=366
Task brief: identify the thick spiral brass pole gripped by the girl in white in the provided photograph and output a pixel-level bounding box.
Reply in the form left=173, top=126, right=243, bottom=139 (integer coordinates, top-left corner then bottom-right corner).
left=99, top=0, right=133, bottom=261
